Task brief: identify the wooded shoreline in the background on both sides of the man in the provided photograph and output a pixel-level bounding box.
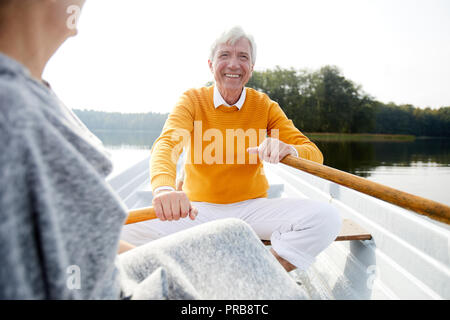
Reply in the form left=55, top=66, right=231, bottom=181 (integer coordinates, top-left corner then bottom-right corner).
left=74, top=66, right=450, bottom=137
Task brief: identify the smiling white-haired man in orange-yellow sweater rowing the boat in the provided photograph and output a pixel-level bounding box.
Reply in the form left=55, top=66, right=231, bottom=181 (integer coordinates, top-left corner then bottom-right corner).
left=122, top=27, right=341, bottom=271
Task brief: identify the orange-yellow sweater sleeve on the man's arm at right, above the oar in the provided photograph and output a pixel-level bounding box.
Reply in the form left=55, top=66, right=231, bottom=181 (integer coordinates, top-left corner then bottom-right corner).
left=267, top=101, right=323, bottom=163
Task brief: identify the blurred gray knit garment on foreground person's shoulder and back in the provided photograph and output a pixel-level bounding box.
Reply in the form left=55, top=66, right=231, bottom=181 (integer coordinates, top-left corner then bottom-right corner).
left=0, top=54, right=126, bottom=299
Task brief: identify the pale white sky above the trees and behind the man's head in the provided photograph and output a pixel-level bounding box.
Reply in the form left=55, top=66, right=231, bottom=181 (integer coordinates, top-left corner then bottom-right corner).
left=44, top=0, right=450, bottom=113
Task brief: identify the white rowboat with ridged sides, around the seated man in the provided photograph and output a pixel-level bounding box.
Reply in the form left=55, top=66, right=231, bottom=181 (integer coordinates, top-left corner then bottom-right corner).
left=108, top=158, right=450, bottom=299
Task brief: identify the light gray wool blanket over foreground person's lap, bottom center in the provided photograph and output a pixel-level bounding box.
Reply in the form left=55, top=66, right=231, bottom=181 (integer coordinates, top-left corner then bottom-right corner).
left=119, top=218, right=306, bottom=300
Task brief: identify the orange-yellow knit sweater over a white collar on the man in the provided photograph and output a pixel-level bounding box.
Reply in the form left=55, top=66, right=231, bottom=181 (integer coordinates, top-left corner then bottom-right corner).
left=150, top=86, right=323, bottom=203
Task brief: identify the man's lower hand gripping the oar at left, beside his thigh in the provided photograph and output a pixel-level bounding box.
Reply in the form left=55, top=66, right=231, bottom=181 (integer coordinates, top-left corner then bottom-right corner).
left=152, top=190, right=198, bottom=221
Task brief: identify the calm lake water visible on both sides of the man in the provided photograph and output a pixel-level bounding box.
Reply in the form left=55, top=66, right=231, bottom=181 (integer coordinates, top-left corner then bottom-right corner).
left=94, top=131, right=450, bottom=205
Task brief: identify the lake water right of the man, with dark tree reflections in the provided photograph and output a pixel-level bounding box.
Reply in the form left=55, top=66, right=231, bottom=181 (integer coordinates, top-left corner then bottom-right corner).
left=315, top=139, right=450, bottom=205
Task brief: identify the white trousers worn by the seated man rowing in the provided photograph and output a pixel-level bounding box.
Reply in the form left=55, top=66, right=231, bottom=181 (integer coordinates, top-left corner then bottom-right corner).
left=121, top=198, right=342, bottom=270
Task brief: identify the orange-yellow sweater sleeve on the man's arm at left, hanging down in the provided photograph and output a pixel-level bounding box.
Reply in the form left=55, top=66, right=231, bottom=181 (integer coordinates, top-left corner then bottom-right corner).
left=150, top=94, right=194, bottom=190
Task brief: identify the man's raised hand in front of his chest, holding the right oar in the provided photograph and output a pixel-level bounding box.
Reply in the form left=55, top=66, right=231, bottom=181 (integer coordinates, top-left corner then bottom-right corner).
left=247, top=138, right=297, bottom=163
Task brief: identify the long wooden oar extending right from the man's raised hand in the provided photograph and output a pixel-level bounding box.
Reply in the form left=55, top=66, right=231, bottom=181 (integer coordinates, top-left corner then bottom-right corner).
left=281, top=155, right=450, bottom=224
